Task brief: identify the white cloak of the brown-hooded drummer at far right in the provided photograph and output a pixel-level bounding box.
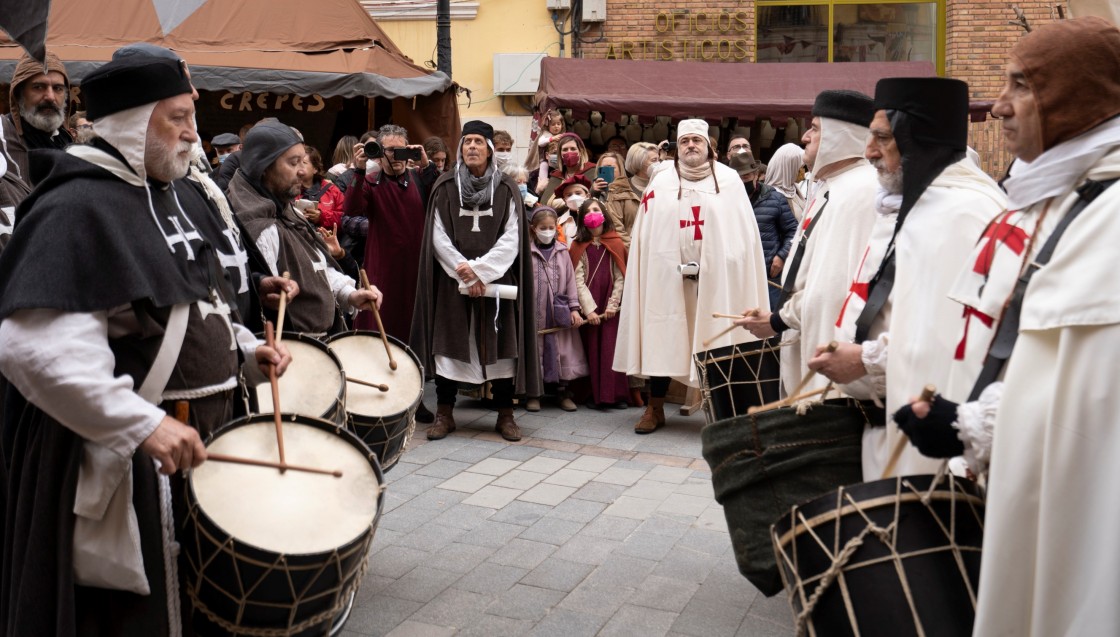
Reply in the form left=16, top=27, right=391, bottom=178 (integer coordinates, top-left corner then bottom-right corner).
left=973, top=144, right=1120, bottom=637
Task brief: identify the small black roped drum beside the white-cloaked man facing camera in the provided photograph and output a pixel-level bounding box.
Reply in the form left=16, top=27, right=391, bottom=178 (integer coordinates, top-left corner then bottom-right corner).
left=693, top=338, right=782, bottom=422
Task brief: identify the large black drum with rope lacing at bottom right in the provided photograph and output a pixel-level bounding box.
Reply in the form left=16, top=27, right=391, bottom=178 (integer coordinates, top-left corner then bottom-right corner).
left=772, top=475, right=984, bottom=637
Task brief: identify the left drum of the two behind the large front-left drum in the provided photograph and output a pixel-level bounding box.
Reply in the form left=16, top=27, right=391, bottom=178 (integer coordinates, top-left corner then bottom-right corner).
left=250, top=331, right=346, bottom=424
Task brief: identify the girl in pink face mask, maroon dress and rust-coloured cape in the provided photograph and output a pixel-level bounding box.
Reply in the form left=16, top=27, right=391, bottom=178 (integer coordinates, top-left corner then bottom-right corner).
left=568, top=199, right=629, bottom=409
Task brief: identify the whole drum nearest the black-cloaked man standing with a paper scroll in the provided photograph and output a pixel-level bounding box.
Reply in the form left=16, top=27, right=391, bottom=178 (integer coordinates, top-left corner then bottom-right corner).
left=327, top=330, right=423, bottom=471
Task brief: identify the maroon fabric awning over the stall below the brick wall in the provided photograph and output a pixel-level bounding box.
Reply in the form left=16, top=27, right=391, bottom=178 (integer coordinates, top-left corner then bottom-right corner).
left=533, top=57, right=992, bottom=121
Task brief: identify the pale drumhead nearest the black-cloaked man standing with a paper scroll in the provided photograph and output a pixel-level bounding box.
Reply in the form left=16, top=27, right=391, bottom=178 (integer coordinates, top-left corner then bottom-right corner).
left=327, top=332, right=423, bottom=416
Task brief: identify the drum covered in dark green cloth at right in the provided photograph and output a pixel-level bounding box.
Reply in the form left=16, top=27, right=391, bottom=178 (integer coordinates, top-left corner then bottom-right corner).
left=701, top=404, right=867, bottom=596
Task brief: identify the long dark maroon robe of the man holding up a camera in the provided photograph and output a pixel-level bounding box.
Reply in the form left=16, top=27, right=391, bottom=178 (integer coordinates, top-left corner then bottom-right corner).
left=343, top=153, right=439, bottom=341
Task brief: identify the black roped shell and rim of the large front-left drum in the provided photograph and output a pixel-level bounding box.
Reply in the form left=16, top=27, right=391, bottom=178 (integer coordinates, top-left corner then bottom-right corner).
left=179, top=414, right=385, bottom=636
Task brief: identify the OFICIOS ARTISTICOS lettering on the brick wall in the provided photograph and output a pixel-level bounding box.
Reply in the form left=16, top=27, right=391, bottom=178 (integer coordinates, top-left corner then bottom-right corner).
left=606, top=10, right=753, bottom=60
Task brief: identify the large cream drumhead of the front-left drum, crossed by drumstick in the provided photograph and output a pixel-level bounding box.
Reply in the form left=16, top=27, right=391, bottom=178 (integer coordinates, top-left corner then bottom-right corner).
left=189, top=421, right=381, bottom=554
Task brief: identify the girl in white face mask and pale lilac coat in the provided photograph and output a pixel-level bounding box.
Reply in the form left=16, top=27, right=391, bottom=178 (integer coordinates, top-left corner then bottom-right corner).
left=525, top=206, right=587, bottom=411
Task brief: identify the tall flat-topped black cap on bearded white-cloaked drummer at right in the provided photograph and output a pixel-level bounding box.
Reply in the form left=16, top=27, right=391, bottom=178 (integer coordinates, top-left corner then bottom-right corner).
left=875, top=77, right=969, bottom=150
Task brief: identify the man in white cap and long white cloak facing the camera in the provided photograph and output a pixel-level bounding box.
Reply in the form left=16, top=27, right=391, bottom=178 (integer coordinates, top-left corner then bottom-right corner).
left=614, top=120, right=769, bottom=433
